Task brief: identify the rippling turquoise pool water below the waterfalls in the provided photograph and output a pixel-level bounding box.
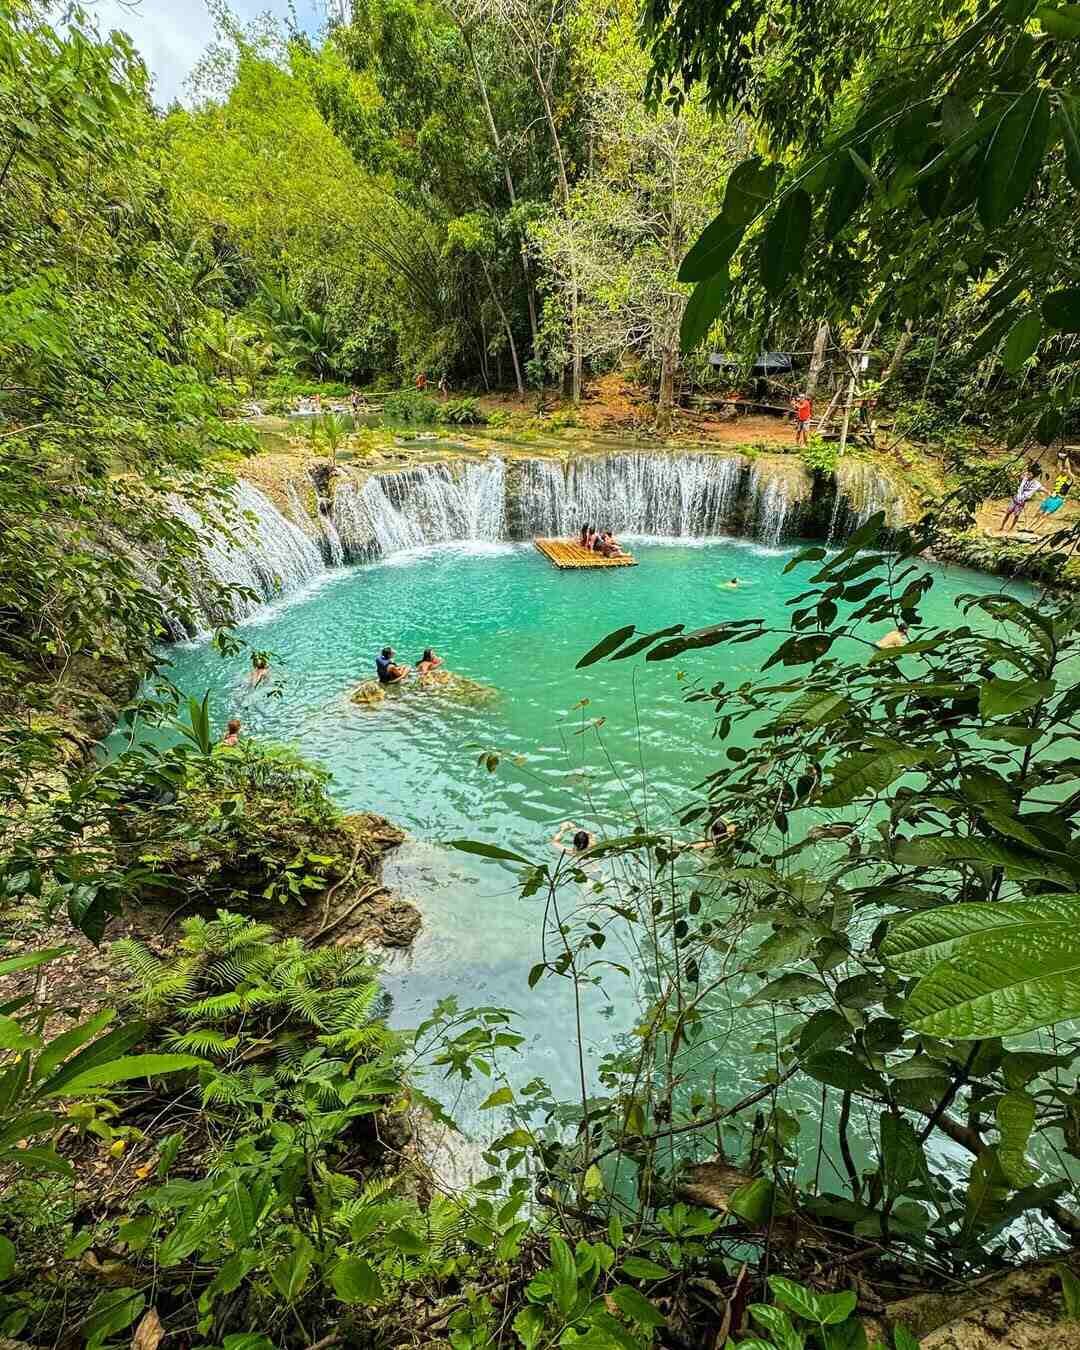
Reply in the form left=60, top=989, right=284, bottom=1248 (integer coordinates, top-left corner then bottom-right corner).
left=151, top=540, right=1020, bottom=1155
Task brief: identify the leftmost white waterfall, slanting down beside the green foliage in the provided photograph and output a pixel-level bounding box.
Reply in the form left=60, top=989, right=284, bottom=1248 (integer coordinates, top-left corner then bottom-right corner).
left=173, top=479, right=324, bottom=626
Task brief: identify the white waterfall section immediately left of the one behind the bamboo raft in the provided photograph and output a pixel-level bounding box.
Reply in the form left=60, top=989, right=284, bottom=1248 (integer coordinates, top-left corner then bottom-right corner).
left=333, top=459, right=506, bottom=562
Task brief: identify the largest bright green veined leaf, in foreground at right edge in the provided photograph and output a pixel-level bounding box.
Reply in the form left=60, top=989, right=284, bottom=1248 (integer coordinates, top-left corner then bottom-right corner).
left=886, top=895, right=1080, bottom=1040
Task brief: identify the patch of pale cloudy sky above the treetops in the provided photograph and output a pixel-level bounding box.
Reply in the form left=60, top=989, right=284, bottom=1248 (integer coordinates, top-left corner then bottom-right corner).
left=86, top=0, right=327, bottom=105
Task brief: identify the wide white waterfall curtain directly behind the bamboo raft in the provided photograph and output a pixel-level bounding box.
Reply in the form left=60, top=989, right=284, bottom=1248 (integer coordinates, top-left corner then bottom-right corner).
left=514, top=454, right=744, bottom=539
